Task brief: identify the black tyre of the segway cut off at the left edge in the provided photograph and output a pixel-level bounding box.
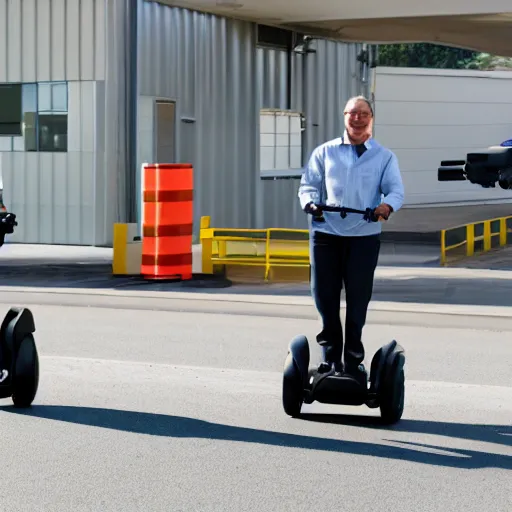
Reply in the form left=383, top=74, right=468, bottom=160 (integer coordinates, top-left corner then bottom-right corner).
left=12, top=334, right=39, bottom=407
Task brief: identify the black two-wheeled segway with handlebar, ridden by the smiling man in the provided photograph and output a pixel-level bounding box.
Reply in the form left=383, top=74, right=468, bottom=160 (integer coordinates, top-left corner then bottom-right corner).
left=282, top=205, right=405, bottom=424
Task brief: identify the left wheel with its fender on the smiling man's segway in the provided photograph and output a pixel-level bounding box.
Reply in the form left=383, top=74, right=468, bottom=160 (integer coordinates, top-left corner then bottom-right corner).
left=282, top=336, right=309, bottom=417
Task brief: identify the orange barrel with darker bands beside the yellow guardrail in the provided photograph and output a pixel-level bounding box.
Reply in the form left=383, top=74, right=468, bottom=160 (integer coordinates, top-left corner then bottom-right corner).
left=141, top=164, right=194, bottom=280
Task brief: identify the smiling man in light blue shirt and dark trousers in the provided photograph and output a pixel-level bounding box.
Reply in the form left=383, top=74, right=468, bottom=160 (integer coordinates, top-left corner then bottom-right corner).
left=298, top=96, right=404, bottom=382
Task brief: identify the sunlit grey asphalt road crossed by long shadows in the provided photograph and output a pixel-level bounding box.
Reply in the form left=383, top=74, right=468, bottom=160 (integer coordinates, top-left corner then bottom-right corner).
left=0, top=288, right=512, bottom=512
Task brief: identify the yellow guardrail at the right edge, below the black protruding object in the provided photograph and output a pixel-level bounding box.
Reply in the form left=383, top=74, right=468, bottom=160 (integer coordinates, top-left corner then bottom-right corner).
left=441, top=216, right=512, bottom=265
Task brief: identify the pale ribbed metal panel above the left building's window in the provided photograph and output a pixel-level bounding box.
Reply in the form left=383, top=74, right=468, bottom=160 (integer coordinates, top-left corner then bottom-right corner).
left=0, top=0, right=105, bottom=82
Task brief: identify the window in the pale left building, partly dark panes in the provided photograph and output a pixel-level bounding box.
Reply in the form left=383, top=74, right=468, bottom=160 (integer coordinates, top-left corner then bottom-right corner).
left=0, top=82, right=68, bottom=152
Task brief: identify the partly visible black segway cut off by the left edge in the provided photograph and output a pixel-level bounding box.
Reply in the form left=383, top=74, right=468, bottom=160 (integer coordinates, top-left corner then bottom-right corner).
left=0, top=308, right=39, bottom=407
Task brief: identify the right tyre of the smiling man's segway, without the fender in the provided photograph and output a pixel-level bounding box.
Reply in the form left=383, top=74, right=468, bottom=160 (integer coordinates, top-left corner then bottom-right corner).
left=380, top=353, right=405, bottom=425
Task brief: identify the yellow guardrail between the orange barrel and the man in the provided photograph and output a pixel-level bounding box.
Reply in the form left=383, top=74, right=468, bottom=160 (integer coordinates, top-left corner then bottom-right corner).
left=200, top=216, right=309, bottom=281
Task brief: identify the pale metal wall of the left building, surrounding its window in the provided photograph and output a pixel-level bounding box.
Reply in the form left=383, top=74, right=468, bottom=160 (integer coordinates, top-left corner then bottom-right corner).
left=0, top=0, right=129, bottom=245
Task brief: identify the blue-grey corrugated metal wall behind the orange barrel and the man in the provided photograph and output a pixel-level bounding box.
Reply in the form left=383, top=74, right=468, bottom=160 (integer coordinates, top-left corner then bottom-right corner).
left=137, top=0, right=364, bottom=233
